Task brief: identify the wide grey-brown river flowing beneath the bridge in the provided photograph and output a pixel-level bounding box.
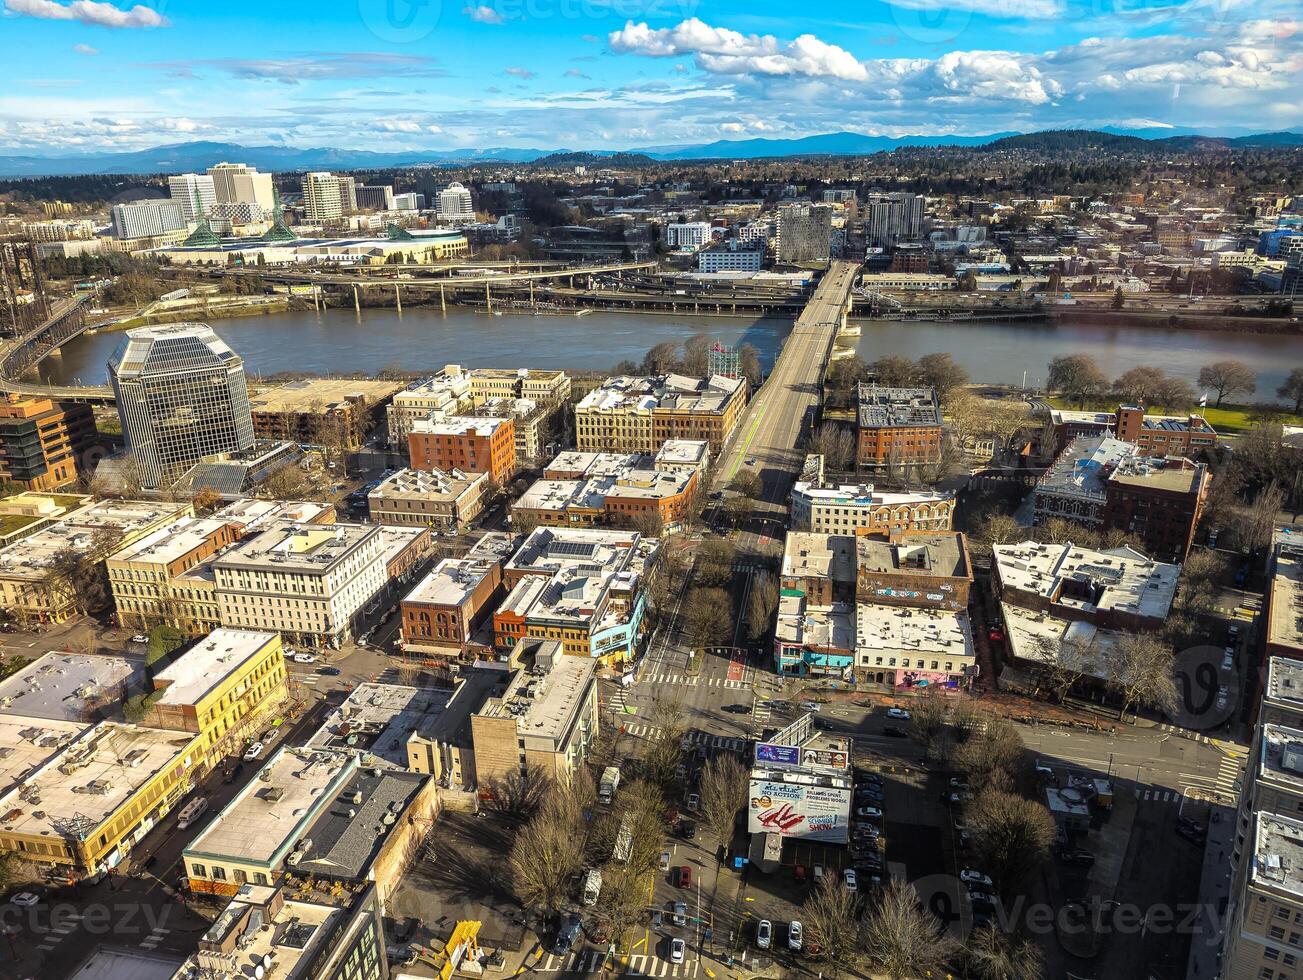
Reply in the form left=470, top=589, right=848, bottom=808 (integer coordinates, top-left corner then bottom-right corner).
left=33, top=308, right=1303, bottom=400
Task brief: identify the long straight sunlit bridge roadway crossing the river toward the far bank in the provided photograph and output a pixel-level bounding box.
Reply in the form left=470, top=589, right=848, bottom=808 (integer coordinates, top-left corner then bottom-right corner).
left=715, top=262, right=859, bottom=508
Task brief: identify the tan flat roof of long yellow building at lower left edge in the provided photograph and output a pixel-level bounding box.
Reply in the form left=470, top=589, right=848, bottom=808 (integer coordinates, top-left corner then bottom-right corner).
left=0, top=722, right=199, bottom=838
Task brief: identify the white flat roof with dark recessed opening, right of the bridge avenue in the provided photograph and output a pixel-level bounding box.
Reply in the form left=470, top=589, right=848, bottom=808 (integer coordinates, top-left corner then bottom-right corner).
left=992, top=541, right=1181, bottom=619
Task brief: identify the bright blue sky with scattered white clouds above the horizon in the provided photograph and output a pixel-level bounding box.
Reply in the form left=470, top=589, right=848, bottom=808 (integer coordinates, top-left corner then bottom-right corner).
left=0, top=0, right=1303, bottom=154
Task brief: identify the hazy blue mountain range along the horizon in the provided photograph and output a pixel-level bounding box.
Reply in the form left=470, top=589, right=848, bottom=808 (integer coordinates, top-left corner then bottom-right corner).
left=0, top=128, right=1303, bottom=177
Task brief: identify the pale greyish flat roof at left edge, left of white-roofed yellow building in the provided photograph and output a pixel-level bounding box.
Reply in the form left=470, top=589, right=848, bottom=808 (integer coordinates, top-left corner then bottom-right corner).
left=0, top=652, right=145, bottom=722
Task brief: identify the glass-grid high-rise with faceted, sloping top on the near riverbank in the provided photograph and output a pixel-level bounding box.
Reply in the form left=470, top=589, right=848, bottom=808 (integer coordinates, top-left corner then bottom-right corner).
left=108, top=323, right=254, bottom=487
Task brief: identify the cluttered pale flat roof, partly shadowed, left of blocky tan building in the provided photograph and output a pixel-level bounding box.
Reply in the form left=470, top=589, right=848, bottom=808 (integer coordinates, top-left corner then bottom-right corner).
left=308, top=684, right=452, bottom=769
